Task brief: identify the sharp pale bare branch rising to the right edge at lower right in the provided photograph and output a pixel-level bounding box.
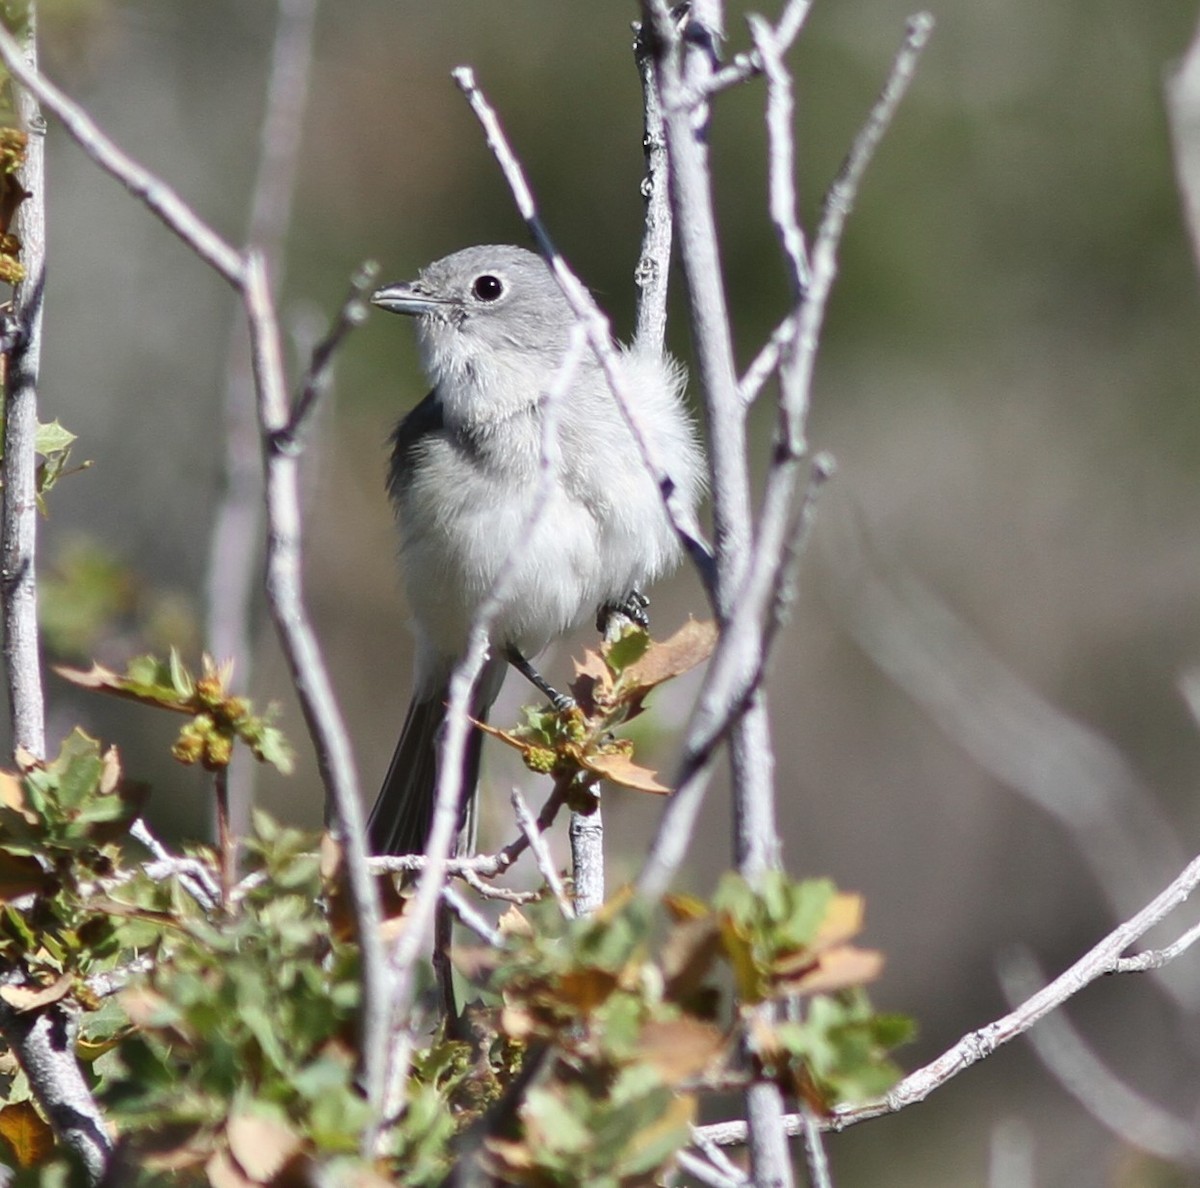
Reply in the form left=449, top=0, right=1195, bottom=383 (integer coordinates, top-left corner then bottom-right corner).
left=697, top=858, right=1200, bottom=1146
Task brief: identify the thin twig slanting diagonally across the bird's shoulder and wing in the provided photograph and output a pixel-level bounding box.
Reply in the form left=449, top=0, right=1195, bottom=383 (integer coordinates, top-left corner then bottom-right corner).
left=452, top=66, right=713, bottom=588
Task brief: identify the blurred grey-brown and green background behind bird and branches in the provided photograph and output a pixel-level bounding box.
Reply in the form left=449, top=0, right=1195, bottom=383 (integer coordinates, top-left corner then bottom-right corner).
left=14, top=0, right=1200, bottom=1188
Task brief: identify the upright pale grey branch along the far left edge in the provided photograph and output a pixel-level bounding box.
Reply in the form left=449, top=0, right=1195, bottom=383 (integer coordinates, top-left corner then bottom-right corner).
left=0, top=4, right=46, bottom=758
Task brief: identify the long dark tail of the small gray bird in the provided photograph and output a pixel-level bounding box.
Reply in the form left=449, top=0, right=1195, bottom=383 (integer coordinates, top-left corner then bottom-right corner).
left=367, top=677, right=496, bottom=854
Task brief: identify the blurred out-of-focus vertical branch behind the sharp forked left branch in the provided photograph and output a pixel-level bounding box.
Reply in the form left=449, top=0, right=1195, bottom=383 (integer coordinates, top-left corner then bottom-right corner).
left=204, top=0, right=317, bottom=834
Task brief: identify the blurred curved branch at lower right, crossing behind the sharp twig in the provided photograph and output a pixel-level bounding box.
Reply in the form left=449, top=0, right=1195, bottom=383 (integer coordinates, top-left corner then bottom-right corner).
left=998, top=946, right=1200, bottom=1166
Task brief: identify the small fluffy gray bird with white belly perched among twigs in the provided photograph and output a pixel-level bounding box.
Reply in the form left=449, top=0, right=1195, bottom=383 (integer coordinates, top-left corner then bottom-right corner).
left=368, top=246, right=703, bottom=854
